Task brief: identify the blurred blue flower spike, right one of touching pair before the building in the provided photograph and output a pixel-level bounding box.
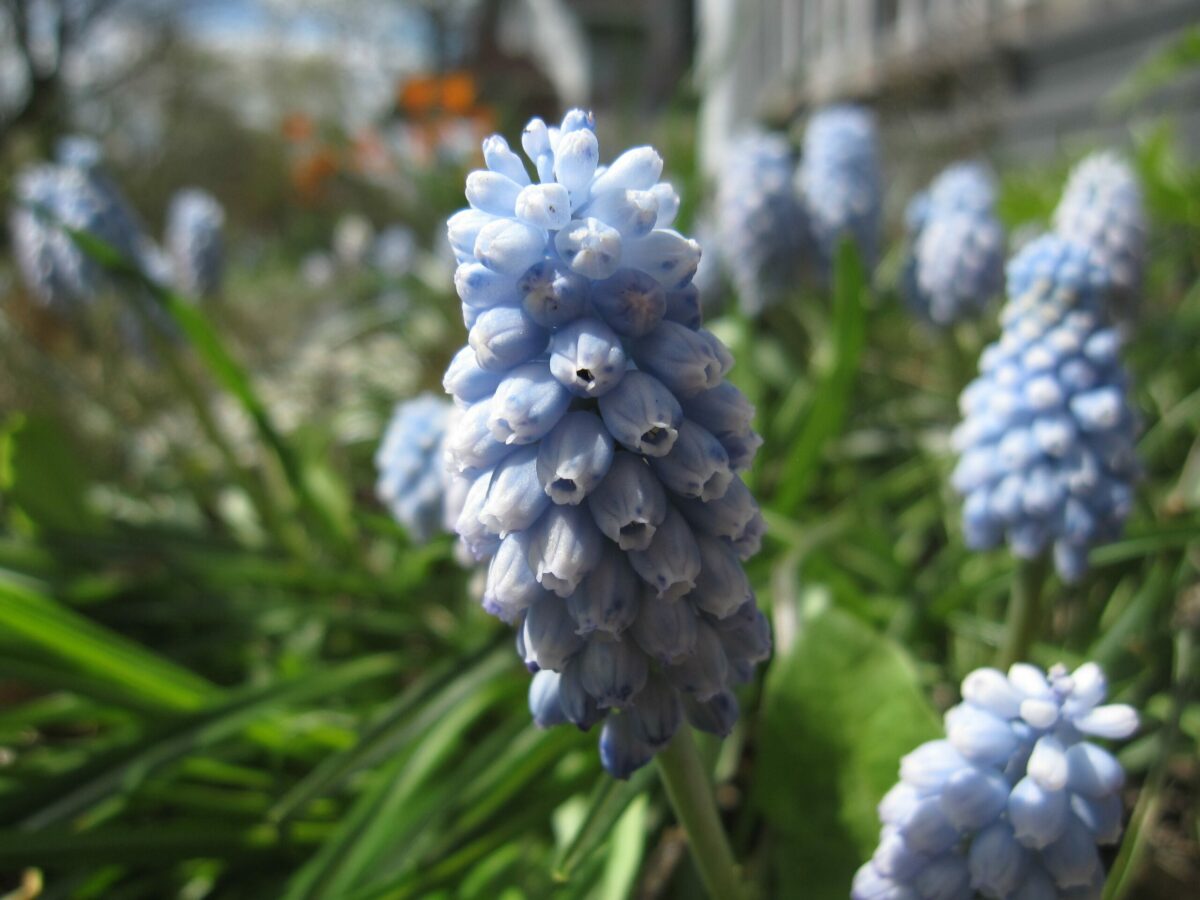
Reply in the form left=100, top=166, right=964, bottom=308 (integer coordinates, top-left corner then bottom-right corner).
left=797, top=106, right=883, bottom=272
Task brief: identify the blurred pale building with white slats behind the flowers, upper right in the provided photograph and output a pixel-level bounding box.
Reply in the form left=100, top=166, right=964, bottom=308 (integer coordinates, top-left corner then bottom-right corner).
left=696, top=0, right=1200, bottom=175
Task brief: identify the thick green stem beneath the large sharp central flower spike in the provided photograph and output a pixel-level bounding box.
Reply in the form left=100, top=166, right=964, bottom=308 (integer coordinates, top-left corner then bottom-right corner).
left=655, top=725, right=744, bottom=900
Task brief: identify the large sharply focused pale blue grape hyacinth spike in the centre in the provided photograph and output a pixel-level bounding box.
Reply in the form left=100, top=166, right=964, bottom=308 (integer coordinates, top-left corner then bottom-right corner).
left=445, top=110, right=770, bottom=778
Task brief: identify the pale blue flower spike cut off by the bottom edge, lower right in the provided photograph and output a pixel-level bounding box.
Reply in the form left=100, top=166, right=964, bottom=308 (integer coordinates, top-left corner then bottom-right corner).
left=851, top=662, right=1138, bottom=900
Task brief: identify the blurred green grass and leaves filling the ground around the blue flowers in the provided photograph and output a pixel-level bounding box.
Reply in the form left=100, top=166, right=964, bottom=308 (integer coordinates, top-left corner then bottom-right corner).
left=0, top=42, right=1200, bottom=900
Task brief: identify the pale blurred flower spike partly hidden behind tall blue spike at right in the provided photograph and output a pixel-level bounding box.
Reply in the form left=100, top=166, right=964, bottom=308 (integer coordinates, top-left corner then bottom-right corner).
left=1054, top=152, right=1146, bottom=302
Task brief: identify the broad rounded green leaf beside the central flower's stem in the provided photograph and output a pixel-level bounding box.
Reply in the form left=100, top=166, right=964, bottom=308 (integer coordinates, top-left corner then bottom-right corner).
left=752, top=604, right=940, bottom=898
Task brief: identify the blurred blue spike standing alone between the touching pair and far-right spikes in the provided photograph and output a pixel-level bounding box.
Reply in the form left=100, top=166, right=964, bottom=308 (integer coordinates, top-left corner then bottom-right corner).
left=901, top=163, right=1004, bottom=325
